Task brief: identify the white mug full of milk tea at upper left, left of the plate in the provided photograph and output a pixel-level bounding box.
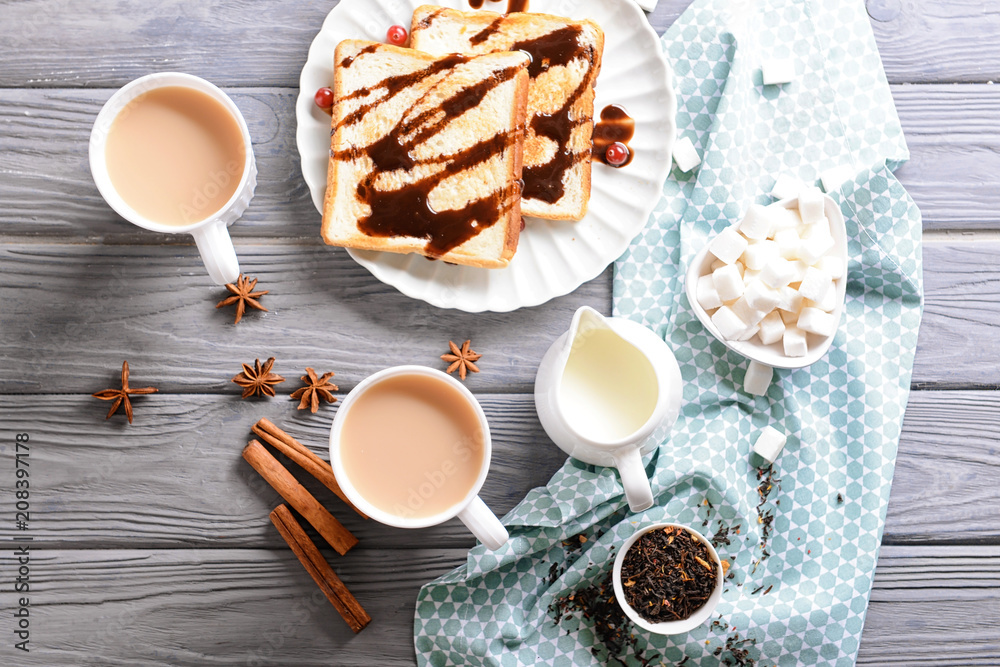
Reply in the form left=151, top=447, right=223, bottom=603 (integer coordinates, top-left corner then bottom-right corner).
left=90, top=72, right=257, bottom=285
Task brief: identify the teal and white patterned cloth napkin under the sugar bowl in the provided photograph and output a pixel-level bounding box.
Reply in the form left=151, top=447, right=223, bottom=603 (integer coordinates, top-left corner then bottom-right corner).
left=414, top=0, right=922, bottom=667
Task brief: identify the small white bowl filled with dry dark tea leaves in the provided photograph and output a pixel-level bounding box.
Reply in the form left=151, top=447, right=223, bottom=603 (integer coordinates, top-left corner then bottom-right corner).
left=613, top=523, right=725, bottom=635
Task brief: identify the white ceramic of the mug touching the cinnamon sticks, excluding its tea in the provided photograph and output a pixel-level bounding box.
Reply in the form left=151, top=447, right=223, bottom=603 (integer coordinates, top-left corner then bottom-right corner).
left=330, top=366, right=508, bottom=551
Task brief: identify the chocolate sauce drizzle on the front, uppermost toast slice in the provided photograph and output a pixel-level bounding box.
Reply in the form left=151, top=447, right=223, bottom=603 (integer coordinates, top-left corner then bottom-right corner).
left=332, top=55, right=524, bottom=257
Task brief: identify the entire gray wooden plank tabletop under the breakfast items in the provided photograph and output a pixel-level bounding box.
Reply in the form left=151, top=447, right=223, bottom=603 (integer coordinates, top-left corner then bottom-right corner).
left=0, top=0, right=1000, bottom=666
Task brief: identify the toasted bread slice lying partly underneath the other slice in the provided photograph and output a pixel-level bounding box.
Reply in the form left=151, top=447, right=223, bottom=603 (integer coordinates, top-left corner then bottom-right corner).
left=410, top=5, right=604, bottom=220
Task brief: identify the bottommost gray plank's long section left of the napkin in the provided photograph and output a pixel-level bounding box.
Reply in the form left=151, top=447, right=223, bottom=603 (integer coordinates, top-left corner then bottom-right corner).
left=0, top=546, right=465, bottom=667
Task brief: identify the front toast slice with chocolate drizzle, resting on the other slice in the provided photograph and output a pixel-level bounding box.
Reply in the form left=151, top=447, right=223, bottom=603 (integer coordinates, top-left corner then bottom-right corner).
left=323, top=40, right=528, bottom=268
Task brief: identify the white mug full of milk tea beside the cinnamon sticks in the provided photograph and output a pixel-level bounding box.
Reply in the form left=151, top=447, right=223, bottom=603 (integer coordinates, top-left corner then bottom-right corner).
left=330, top=366, right=508, bottom=551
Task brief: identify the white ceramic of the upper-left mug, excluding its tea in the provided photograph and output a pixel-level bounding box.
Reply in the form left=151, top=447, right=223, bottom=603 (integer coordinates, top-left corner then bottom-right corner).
left=90, top=72, right=257, bottom=285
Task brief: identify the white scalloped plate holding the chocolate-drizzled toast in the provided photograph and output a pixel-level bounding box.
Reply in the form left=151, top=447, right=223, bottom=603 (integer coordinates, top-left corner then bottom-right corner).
left=295, top=0, right=677, bottom=312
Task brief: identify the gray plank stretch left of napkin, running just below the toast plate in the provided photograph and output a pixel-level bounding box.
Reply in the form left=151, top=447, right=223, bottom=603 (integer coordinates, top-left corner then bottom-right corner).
left=0, top=244, right=611, bottom=394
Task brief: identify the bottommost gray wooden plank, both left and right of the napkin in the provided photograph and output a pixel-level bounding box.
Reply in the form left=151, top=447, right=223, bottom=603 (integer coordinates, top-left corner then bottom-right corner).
left=0, top=545, right=1000, bottom=667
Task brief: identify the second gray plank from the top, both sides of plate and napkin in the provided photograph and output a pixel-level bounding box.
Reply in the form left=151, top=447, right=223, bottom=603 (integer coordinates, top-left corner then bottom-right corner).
left=0, top=85, right=1000, bottom=239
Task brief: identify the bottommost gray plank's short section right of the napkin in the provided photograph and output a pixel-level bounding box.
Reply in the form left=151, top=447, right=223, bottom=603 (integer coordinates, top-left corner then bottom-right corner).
left=858, top=546, right=1000, bottom=667
